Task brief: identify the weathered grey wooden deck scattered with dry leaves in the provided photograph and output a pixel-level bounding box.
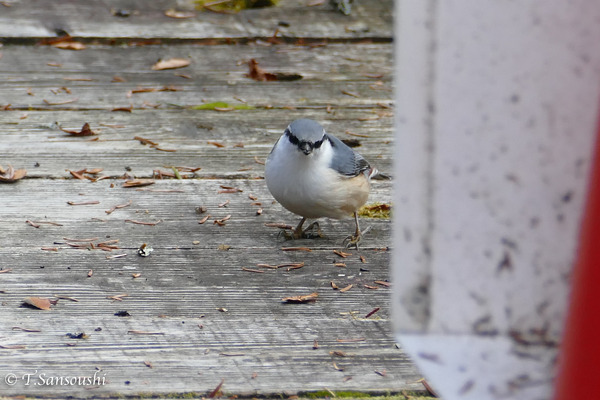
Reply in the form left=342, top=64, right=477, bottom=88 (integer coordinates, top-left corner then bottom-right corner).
left=0, top=0, right=424, bottom=398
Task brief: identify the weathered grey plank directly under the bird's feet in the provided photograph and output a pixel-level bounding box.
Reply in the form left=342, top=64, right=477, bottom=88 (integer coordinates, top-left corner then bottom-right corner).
left=0, top=179, right=391, bottom=247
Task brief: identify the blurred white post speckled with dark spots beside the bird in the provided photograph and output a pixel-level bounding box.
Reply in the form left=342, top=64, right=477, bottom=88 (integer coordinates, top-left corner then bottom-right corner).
left=393, top=0, right=600, bottom=400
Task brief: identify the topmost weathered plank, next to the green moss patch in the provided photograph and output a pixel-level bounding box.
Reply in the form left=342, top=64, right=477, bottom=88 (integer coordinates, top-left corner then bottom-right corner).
left=0, top=0, right=393, bottom=40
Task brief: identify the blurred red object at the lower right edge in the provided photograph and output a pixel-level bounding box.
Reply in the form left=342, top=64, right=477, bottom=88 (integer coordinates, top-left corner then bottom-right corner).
left=554, top=118, right=600, bottom=400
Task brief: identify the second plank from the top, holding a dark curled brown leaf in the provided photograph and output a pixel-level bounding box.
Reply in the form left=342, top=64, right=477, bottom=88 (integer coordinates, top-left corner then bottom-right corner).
left=0, top=44, right=392, bottom=110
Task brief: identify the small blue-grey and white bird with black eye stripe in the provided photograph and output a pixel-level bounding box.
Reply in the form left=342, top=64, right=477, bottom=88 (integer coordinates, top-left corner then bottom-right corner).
left=265, top=118, right=379, bottom=248
